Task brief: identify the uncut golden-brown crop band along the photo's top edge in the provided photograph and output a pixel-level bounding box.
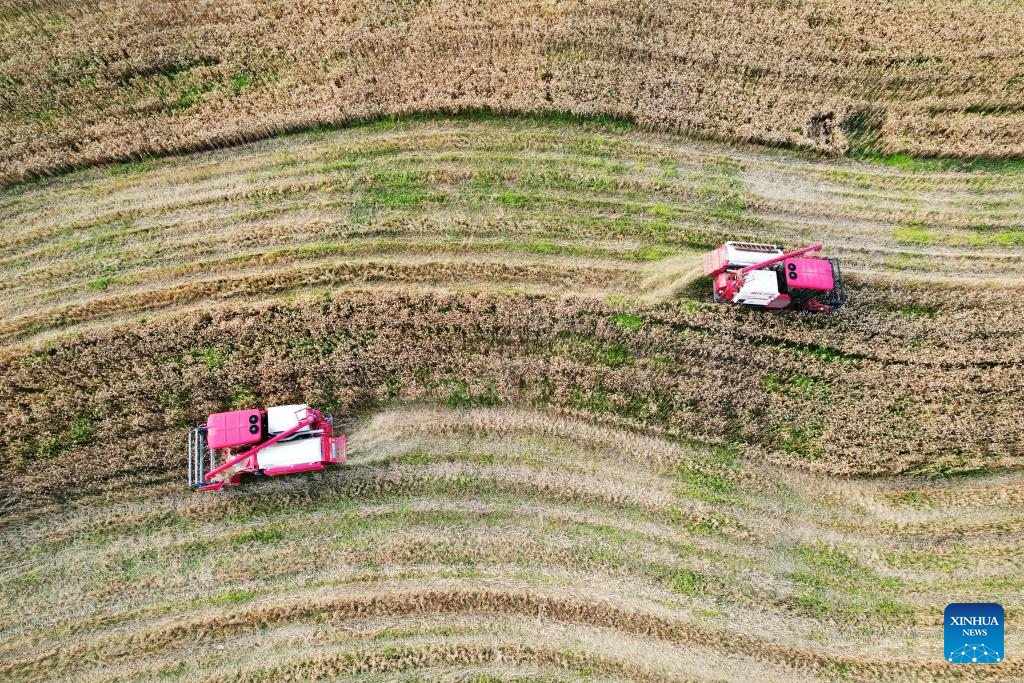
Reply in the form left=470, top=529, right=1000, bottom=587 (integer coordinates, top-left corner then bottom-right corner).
left=0, top=0, right=1024, bottom=179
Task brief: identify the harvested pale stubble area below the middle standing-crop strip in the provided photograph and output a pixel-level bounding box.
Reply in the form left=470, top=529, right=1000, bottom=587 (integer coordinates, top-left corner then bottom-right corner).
left=0, top=407, right=1020, bottom=680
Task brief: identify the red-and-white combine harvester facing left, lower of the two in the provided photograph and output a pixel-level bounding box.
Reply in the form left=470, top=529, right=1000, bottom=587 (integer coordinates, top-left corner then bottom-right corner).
left=188, top=404, right=345, bottom=490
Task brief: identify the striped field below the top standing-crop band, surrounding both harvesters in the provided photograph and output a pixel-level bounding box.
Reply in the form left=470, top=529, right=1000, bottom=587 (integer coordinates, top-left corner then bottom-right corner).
left=0, top=114, right=1024, bottom=682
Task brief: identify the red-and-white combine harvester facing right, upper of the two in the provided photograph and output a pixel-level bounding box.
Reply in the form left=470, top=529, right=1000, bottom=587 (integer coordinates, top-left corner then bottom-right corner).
left=703, top=242, right=846, bottom=313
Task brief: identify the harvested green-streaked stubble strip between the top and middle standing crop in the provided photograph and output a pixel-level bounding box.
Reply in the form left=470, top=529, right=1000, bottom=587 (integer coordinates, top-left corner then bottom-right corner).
left=0, top=119, right=1024, bottom=348
